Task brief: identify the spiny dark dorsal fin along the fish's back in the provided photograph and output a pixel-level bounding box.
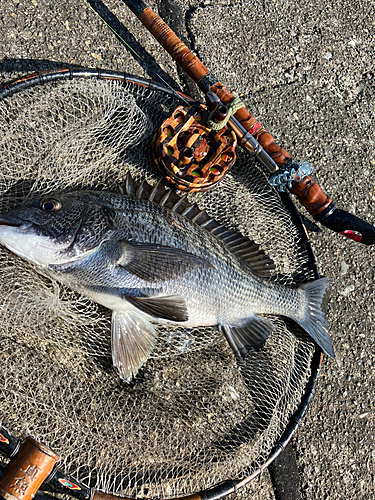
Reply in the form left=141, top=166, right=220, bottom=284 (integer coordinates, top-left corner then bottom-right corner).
left=125, top=173, right=275, bottom=278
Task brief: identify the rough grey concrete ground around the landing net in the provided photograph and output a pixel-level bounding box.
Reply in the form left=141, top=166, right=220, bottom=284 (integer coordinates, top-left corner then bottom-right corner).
left=0, top=0, right=375, bottom=500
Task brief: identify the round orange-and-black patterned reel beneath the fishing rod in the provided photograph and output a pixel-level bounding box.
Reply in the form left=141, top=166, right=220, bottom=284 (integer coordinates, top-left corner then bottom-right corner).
left=152, top=104, right=237, bottom=192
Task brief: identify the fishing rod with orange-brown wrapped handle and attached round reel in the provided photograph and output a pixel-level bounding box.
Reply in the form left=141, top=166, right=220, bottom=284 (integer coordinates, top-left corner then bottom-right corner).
left=123, top=0, right=375, bottom=245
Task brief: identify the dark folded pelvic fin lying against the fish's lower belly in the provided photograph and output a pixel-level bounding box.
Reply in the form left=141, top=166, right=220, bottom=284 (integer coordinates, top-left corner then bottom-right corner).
left=124, top=295, right=189, bottom=323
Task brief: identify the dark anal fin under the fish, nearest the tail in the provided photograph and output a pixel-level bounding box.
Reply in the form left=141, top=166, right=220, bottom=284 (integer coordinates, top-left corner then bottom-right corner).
left=220, top=316, right=275, bottom=359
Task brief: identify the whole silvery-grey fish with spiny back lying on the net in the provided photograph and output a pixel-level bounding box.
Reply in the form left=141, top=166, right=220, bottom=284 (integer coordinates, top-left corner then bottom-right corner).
left=0, top=174, right=334, bottom=382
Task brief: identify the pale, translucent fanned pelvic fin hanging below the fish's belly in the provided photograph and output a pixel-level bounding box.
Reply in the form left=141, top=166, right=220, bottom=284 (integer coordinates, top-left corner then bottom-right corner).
left=112, top=311, right=156, bottom=382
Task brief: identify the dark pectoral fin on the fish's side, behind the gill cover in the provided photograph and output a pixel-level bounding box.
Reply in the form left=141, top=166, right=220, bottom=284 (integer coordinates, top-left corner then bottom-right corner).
left=117, top=241, right=213, bottom=281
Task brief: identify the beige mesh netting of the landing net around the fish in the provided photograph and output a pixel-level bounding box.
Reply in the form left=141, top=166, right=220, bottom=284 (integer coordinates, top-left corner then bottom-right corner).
left=0, top=78, right=314, bottom=498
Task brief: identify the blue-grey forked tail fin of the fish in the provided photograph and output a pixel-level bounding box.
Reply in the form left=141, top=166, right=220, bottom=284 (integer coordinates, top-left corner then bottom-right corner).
left=292, top=278, right=335, bottom=358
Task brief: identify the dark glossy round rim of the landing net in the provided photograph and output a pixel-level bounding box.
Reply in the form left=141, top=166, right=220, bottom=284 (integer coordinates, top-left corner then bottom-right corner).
left=0, top=67, right=323, bottom=500
